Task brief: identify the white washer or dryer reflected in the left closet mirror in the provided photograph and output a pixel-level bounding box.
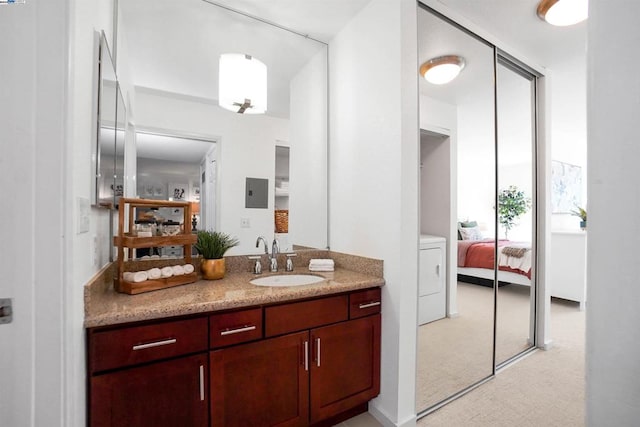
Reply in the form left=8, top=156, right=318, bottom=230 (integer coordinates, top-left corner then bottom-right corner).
left=418, top=234, right=447, bottom=325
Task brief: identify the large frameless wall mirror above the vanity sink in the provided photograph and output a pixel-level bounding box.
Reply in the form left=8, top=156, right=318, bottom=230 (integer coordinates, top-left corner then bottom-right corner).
left=118, top=0, right=328, bottom=255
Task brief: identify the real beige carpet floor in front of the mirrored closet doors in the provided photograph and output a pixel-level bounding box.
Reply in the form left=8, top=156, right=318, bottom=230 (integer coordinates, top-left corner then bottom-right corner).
left=420, top=300, right=585, bottom=427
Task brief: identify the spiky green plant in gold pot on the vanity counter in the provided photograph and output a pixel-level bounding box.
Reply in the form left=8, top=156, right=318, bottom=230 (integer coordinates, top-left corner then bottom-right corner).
left=195, top=230, right=240, bottom=280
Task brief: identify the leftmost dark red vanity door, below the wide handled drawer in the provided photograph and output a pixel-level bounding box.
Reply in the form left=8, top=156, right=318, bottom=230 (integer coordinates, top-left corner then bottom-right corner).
left=90, top=353, right=208, bottom=427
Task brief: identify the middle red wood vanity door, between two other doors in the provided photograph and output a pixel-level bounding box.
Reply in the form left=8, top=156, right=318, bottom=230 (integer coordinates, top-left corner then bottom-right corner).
left=211, top=332, right=309, bottom=427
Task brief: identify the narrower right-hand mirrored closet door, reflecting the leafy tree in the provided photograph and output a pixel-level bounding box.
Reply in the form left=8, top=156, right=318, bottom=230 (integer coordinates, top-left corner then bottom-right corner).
left=496, top=54, right=536, bottom=366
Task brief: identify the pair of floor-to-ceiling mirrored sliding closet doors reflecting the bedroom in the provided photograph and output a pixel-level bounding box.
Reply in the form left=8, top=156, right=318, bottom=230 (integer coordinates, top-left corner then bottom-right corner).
left=416, top=4, right=536, bottom=415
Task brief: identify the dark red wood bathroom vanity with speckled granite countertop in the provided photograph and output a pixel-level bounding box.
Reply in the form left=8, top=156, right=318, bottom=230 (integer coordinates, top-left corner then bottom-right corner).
left=85, top=258, right=384, bottom=426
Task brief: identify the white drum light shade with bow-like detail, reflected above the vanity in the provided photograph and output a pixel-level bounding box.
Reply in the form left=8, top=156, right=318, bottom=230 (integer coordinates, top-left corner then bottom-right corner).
left=218, top=53, right=267, bottom=114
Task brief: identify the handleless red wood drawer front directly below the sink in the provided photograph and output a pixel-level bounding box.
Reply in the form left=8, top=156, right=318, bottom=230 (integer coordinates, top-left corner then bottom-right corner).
left=264, top=295, right=349, bottom=337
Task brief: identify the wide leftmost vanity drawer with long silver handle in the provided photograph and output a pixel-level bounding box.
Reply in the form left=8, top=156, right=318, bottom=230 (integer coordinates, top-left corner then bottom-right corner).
left=89, top=317, right=209, bottom=373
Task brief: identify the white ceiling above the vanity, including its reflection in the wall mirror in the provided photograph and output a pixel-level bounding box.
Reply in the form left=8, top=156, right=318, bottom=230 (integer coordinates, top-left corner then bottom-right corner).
left=120, top=0, right=370, bottom=118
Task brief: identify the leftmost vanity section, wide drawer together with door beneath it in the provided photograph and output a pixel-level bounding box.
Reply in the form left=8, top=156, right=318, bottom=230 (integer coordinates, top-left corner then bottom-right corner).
left=88, top=317, right=209, bottom=427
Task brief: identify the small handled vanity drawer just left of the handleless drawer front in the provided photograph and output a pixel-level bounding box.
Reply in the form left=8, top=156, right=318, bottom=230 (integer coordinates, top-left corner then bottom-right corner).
left=209, top=308, right=262, bottom=347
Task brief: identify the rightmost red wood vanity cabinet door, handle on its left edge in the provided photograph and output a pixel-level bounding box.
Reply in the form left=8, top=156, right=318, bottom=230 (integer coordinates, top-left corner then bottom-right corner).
left=311, top=314, right=380, bottom=423
